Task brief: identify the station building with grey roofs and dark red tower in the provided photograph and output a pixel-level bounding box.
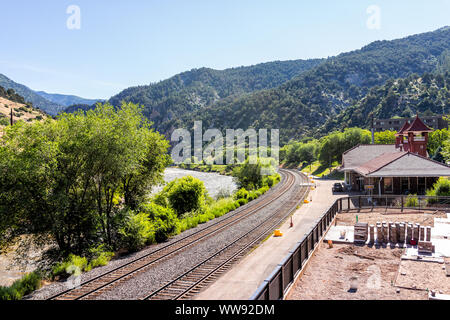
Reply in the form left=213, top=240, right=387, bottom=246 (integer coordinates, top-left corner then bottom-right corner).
left=339, top=116, right=450, bottom=195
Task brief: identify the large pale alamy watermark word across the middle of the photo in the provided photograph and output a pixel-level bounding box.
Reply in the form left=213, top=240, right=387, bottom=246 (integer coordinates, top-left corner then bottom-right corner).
left=171, top=121, right=280, bottom=175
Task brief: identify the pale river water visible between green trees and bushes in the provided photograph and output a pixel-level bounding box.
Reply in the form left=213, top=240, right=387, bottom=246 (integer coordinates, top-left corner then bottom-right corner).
left=152, top=168, right=237, bottom=198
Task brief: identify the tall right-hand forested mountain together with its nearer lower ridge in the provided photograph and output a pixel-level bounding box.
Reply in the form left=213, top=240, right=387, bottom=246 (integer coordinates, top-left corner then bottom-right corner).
left=166, top=29, right=450, bottom=145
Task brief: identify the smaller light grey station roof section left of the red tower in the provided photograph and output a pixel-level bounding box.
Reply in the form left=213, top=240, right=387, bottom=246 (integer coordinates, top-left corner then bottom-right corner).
left=340, top=144, right=398, bottom=171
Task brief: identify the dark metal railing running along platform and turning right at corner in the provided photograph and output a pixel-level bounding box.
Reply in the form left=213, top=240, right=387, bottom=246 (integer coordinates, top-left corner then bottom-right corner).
left=250, top=195, right=450, bottom=300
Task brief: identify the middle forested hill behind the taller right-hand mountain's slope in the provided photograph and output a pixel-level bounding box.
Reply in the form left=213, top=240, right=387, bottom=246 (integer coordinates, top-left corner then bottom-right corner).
left=109, top=59, right=322, bottom=128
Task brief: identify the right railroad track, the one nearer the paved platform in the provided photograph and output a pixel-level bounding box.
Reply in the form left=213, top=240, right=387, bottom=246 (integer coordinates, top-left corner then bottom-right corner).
left=143, top=170, right=309, bottom=300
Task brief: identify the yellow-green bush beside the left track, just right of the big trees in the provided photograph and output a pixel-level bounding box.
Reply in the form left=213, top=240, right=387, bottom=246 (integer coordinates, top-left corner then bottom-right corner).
left=140, top=202, right=179, bottom=242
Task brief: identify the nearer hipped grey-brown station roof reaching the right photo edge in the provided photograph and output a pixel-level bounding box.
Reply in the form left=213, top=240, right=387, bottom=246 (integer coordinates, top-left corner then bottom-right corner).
left=361, top=152, right=450, bottom=177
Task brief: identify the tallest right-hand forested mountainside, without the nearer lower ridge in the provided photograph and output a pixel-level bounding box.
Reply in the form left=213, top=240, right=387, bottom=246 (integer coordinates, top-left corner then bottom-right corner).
left=167, top=27, right=450, bottom=143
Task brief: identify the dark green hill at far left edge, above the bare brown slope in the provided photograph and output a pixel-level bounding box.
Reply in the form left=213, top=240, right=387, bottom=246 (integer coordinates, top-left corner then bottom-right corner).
left=0, top=74, right=64, bottom=115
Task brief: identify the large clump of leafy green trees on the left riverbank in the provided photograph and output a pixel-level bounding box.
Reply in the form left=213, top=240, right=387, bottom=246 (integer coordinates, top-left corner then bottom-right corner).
left=0, top=104, right=170, bottom=255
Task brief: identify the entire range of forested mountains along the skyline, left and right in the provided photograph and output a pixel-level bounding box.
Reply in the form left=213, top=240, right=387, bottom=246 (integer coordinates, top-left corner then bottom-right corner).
left=0, top=27, right=450, bottom=144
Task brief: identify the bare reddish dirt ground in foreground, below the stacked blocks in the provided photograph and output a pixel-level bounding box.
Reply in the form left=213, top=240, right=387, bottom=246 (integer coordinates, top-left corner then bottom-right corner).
left=288, top=243, right=428, bottom=300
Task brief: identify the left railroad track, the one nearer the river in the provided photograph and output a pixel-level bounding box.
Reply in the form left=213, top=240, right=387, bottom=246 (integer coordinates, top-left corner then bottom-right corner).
left=48, top=170, right=308, bottom=300
